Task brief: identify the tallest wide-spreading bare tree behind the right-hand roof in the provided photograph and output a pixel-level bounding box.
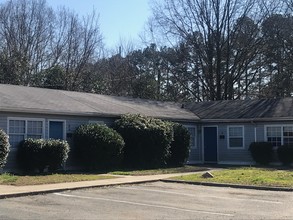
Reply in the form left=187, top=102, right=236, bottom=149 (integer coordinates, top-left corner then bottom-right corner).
left=148, top=0, right=262, bottom=101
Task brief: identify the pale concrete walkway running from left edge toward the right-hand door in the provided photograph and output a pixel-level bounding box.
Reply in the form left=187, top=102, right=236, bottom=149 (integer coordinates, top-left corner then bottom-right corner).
left=0, top=172, right=198, bottom=199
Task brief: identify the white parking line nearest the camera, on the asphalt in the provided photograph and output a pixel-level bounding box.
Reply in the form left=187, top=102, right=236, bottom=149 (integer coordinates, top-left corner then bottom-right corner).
left=54, top=193, right=234, bottom=217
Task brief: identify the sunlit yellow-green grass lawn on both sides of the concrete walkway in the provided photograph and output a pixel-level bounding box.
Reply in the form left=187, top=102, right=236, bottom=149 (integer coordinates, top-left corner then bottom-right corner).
left=0, top=166, right=293, bottom=188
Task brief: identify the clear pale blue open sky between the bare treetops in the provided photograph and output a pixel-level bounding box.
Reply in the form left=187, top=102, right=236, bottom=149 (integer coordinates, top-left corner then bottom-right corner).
left=47, top=0, right=151, bottom=48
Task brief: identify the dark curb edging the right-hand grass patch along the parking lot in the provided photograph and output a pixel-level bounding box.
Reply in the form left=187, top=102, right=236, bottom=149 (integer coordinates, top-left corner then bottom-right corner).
left=160, top=179, right=293, bottom=192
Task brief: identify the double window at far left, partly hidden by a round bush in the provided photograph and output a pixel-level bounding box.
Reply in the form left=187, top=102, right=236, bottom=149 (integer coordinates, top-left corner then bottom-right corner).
left=8, top=119, right=44, bottom=147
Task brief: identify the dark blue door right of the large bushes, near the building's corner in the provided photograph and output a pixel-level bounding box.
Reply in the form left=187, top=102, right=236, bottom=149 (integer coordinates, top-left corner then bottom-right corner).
left=203, top=127, right=218, bottom=163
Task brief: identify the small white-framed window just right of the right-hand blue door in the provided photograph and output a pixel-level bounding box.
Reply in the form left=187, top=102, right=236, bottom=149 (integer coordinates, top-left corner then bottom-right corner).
left=228, top=126, right=244, bottom=148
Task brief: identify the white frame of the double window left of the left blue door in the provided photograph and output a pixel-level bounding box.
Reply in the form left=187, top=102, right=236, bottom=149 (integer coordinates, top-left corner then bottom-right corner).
left=7, top=117, right=45, bottom=149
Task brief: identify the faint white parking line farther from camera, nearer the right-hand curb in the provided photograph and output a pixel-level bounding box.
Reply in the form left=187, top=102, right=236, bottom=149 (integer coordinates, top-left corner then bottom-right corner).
left=119, top=187, right=283, bottom=204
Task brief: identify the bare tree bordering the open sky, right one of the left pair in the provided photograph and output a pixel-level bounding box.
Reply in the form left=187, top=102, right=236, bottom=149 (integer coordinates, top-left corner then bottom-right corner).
left=51, top=8, right=103, bottom=90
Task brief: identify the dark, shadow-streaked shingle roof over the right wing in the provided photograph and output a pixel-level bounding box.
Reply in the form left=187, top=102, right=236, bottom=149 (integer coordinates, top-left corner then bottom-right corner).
left=185, top=98, right=293, bottom=120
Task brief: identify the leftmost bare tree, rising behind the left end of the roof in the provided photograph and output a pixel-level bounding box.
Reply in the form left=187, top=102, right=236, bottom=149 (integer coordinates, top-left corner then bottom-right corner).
left=0, top=0, right=53, bottom=85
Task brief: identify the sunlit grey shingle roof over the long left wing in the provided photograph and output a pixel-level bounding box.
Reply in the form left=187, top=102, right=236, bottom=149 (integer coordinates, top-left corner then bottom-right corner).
left=0, top=84, right=199, bottom=121
